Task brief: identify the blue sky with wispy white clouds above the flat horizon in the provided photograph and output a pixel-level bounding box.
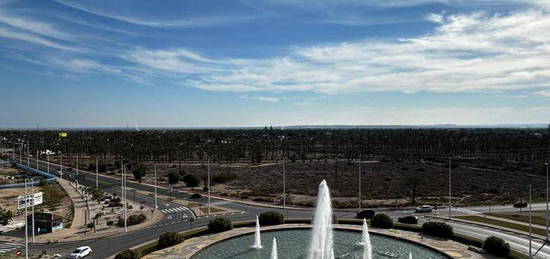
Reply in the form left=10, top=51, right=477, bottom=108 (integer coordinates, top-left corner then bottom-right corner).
left=0, top=0, right=550, bottom=128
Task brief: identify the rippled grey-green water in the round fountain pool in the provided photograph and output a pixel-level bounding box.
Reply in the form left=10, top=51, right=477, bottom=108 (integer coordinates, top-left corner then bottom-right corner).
left=192, top=228, right=449, bottom=259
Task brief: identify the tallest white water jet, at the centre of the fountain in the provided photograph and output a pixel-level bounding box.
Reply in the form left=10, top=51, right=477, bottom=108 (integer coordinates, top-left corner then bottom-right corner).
left=308, top=180, right=334, bottom=259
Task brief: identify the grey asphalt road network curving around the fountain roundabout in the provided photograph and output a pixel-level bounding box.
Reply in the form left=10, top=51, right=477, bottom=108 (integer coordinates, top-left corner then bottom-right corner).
left=8, top=159, right=550, bottom=258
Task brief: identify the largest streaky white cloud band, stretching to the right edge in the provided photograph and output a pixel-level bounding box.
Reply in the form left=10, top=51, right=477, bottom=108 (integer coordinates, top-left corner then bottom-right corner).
left=128, top=10, right=550, bottom=94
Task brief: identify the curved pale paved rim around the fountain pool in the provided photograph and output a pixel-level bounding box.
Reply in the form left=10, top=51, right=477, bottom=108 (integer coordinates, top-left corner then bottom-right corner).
left=190, top=224, right=453, bottom=259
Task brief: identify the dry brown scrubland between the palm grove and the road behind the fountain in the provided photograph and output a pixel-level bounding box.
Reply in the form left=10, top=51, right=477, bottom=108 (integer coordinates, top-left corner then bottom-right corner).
left=135, top=158, right=545, bottom=207
